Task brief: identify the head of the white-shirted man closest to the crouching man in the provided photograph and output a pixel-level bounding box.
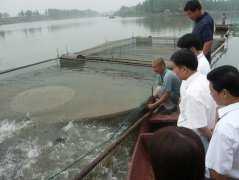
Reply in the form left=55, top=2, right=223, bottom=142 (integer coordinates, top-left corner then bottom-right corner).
left=171, top=49, right=198, bottom=80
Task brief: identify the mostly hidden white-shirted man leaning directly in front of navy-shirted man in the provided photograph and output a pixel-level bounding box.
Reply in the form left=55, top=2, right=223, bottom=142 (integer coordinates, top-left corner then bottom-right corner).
left=177, top=33, right=211, bottom=75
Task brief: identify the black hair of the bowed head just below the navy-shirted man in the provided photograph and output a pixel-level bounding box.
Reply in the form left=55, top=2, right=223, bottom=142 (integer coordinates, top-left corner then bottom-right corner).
left=177, top=33, right=203, bottom=51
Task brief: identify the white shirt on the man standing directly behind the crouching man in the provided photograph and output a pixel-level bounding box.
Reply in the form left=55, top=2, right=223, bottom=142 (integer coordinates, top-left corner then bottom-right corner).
left=177, top=72, right=216, bottom=130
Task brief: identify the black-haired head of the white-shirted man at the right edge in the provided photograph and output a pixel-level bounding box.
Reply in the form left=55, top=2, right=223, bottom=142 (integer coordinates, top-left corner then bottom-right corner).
left=207, top=65, right=239, bottom=105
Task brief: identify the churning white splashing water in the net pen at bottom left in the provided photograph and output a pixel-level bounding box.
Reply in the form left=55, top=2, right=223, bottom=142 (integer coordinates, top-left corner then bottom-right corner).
left=0, top=114, right=131, bottom=180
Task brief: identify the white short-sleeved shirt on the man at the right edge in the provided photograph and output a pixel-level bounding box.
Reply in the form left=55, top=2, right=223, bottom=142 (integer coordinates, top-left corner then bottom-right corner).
left=206, top=103, right=239, bottom=179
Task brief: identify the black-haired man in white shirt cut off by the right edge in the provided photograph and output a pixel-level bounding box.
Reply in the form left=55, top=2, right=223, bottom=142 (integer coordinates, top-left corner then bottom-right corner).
left=206, top=66, right=239, bottom=180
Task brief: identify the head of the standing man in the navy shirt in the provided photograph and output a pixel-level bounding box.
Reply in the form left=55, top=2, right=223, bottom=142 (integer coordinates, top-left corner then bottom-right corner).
left=184, top=0, right=202, bottom=21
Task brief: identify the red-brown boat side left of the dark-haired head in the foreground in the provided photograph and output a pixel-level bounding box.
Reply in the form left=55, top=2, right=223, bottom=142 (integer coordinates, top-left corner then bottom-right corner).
left=127, top=113, right=178, bottom=180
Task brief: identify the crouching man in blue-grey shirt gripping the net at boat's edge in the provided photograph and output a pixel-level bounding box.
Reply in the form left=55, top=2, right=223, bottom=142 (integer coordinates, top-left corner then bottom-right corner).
left=148, top=58, right=181, bottom=111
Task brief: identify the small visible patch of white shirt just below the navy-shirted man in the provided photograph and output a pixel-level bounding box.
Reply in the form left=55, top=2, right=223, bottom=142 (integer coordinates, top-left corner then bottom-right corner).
left=197, top=52, right=211, bottom=75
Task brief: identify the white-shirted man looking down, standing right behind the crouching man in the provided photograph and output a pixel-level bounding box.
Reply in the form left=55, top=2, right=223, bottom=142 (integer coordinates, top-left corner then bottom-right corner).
left=171, top=49, right=216, bottom=150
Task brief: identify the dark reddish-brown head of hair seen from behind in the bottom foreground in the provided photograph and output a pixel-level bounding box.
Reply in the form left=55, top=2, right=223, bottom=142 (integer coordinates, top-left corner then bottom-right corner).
left=148, top=126, right=205, bottom=180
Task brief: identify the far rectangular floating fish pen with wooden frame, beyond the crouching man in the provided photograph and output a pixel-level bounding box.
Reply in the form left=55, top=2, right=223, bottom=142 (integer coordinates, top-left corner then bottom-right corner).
left=60, top=36, right=225, bottom=66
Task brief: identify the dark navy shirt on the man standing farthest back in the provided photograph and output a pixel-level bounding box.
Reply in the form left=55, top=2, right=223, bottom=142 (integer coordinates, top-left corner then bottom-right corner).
left=192, top=12, right=214, bottom=44
